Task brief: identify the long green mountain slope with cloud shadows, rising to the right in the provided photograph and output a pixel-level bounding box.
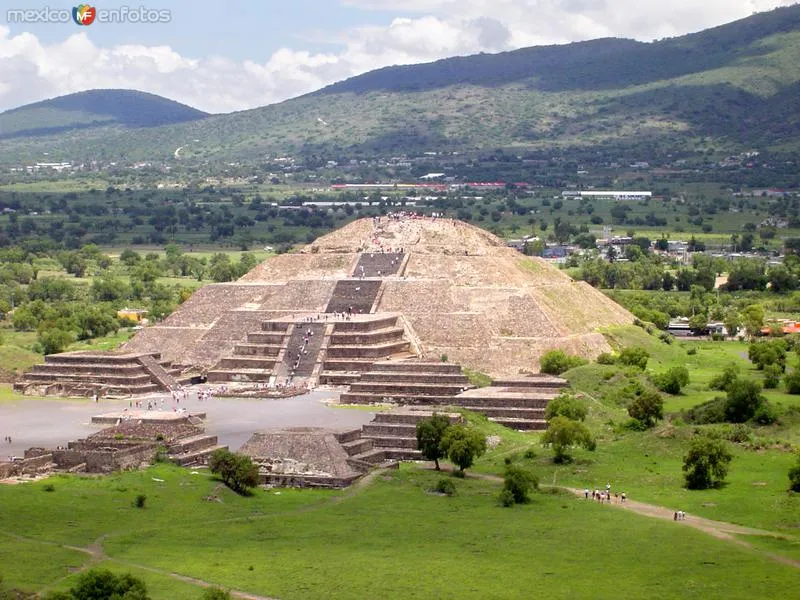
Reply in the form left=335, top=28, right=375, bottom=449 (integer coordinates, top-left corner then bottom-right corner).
left=0, top=5, right=800, bottom=161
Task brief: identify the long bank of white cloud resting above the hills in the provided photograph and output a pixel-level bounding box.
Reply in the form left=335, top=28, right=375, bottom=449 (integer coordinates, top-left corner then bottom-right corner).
left=0, top=0, right=795, bottom=112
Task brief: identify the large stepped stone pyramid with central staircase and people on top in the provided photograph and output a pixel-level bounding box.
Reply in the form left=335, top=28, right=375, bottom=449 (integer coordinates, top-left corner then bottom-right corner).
left=117, top=215, right=633, bottom=383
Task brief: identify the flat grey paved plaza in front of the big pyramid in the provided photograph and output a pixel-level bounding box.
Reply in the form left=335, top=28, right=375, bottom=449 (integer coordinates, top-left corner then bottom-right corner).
left=0, top=390, right=374, bottom=460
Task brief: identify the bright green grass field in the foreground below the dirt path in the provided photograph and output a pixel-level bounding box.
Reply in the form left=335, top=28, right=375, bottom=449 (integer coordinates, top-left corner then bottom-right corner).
left=0, top=465, right=797, bottom=599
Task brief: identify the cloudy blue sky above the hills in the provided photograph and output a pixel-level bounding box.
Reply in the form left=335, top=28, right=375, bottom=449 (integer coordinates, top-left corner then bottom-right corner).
left=0, top=0, right=796, bottom=112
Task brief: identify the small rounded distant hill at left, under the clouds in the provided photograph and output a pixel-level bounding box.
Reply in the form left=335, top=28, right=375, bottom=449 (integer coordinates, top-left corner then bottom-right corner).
left=0, top=90, right=208, bottom=139
